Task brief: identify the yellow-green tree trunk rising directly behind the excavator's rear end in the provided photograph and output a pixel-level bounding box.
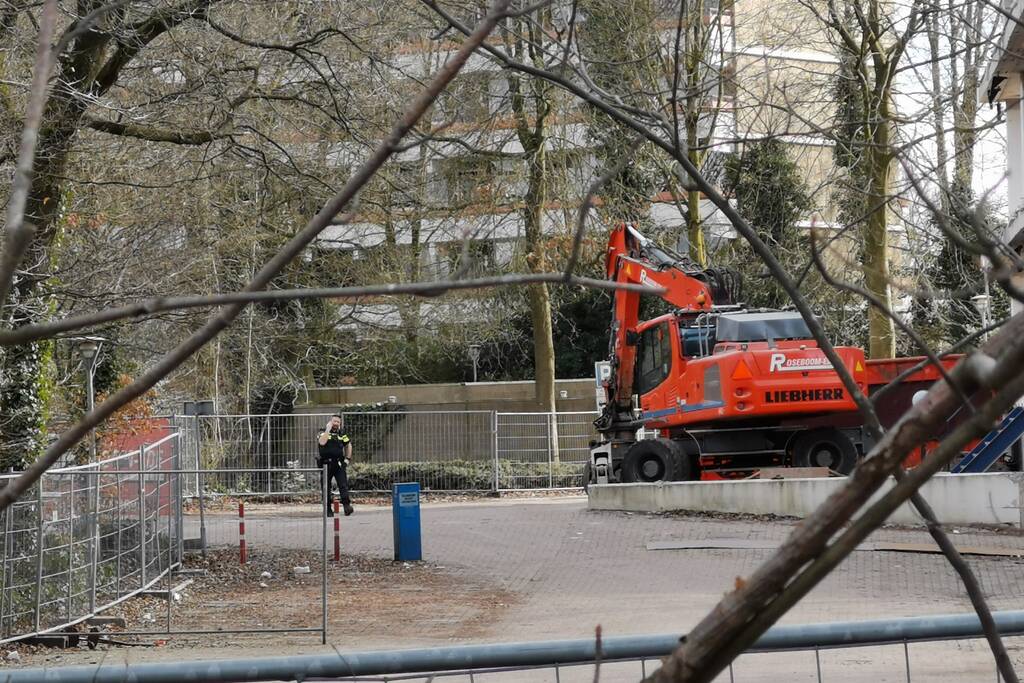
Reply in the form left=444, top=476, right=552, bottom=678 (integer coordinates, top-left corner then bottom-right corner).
left=863, top=104, right=896, bottom=358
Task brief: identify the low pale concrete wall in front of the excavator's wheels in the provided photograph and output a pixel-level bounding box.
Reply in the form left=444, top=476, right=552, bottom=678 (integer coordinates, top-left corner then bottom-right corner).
left=590, top=472, right=1024, bottom=526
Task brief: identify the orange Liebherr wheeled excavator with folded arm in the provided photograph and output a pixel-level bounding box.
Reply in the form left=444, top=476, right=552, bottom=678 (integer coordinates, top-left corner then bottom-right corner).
left=585, top=225, right=955, bottom=483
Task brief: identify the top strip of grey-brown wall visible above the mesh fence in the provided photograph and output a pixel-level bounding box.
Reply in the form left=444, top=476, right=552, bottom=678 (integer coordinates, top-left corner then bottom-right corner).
left=295, top=379, right=597, bottom=413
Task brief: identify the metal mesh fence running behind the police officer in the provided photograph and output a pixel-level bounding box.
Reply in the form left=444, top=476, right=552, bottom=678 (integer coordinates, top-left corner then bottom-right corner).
left=168, top=411, right=596, bottom=496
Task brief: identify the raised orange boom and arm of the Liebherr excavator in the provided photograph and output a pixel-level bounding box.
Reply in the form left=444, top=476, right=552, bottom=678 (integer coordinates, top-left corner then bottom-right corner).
left=597, top=225, right=733, bottom=431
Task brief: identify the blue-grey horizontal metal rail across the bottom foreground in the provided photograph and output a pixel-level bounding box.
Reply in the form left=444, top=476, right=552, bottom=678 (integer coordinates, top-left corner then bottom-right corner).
left=12, top=611, right=1024, bottom=683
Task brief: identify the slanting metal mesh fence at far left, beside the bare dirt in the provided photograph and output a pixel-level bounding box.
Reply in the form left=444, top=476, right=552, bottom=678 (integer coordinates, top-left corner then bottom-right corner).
left=0, top=434, right=182, bottom=641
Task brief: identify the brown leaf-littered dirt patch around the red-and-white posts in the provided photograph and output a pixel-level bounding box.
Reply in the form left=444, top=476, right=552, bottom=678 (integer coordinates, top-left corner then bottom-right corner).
left=12, top=548, right=516, bottom=667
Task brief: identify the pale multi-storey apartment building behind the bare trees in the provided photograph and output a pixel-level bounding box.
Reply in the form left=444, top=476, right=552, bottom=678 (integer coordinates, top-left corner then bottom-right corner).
left=319, top=0, right=838, bottom=326
